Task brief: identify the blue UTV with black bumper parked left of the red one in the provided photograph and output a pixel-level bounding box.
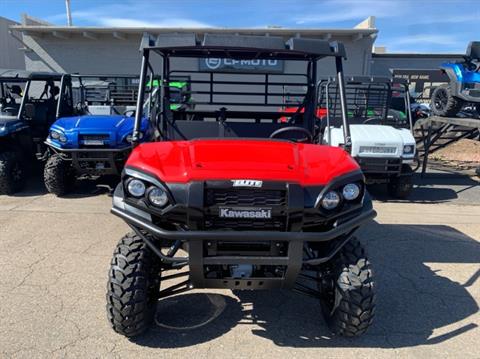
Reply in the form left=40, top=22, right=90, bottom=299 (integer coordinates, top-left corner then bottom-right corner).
left=44, top=75, right=153, bottom=196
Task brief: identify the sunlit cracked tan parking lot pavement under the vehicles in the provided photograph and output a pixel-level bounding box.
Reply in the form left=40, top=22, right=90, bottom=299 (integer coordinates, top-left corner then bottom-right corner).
left=0, top=176, right=480, bottom=358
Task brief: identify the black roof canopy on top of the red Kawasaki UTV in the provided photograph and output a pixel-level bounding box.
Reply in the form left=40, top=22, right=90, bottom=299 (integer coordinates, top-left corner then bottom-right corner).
left=140, top=33, right=346, bottom=61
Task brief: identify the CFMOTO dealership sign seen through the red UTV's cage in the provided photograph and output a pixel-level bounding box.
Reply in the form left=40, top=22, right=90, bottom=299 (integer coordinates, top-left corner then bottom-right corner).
left=199, top=57, right=283, bottom=72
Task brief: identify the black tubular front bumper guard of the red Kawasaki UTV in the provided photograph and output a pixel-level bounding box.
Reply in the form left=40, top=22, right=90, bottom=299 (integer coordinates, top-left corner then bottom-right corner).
left=111, top=194, right=376, bottom=290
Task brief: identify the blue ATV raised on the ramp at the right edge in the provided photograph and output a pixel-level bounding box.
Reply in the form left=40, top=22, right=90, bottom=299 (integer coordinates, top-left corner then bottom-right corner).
left=430, top=41, right=480, bottom=117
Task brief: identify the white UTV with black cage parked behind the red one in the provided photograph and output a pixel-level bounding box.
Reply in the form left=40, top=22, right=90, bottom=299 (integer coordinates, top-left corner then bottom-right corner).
left=319, top=77, right=416, bottom=198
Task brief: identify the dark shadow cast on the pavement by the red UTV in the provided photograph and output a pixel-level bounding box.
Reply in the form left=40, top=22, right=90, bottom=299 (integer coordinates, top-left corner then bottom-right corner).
left=132, top=222, right=480, bottom=348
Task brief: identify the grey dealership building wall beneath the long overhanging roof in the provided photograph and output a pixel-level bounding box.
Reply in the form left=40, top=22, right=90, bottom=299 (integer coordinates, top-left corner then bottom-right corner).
left=23, top=34, right=374, bottom=78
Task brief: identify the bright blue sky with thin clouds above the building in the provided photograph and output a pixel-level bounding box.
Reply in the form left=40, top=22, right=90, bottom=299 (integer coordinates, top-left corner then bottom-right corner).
left=0, top=0, right=480, bottom=53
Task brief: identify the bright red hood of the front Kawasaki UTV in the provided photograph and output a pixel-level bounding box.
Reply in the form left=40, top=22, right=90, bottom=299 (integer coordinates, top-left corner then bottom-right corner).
left=127, top=139, right=359, bottom=186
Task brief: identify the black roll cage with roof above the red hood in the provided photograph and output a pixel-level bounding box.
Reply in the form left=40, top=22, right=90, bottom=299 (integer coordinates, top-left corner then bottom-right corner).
left=133, top=34, right=351, bottom=148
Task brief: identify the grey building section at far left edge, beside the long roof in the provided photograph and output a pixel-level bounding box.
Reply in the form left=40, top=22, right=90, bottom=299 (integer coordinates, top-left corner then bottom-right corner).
left=0, top=16, right=25, bottom=70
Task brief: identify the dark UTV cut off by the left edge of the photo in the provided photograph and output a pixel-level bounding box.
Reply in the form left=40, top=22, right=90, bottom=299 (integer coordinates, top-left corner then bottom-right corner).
left=0, top=69, right=68, bottom=194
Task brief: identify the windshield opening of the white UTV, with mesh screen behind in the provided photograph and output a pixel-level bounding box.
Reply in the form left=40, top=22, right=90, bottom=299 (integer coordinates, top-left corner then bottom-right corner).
left=317, top=80, right=410, bottom=129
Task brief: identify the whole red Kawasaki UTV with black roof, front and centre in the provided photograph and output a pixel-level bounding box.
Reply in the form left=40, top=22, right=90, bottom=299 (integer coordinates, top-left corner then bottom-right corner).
left=106, top=34, right=375, bottom=337
